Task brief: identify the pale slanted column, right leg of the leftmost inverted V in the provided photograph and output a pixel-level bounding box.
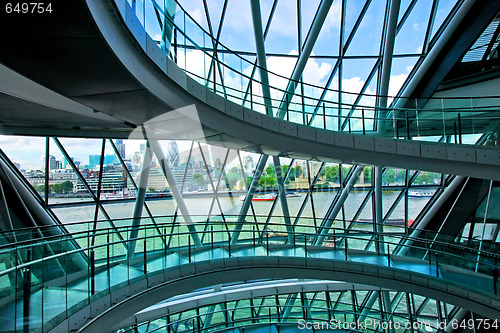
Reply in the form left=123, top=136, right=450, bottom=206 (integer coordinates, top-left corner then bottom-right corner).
left=148, top=139, right=201, bottom=247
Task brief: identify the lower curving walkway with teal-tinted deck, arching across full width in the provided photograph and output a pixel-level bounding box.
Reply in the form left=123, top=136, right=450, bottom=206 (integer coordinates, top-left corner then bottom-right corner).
left=0, top=239, right=500, bottom=332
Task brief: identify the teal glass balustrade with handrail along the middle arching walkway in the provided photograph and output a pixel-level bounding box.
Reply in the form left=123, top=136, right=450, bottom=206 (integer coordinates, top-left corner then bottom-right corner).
left=0, top=216, right=499, bottom=331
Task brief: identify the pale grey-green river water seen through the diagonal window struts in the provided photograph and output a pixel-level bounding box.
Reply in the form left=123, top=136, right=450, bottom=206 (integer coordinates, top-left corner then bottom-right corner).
left=50, top=190, right=430, bottom=230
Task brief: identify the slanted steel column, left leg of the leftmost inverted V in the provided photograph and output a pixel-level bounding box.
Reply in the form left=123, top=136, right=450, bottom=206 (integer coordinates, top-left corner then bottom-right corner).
left=127, top=141, right=153, bottom=258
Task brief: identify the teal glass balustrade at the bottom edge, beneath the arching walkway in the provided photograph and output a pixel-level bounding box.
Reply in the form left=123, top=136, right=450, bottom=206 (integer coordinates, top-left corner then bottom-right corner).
left=119, top=291, right=445, bottom=332
